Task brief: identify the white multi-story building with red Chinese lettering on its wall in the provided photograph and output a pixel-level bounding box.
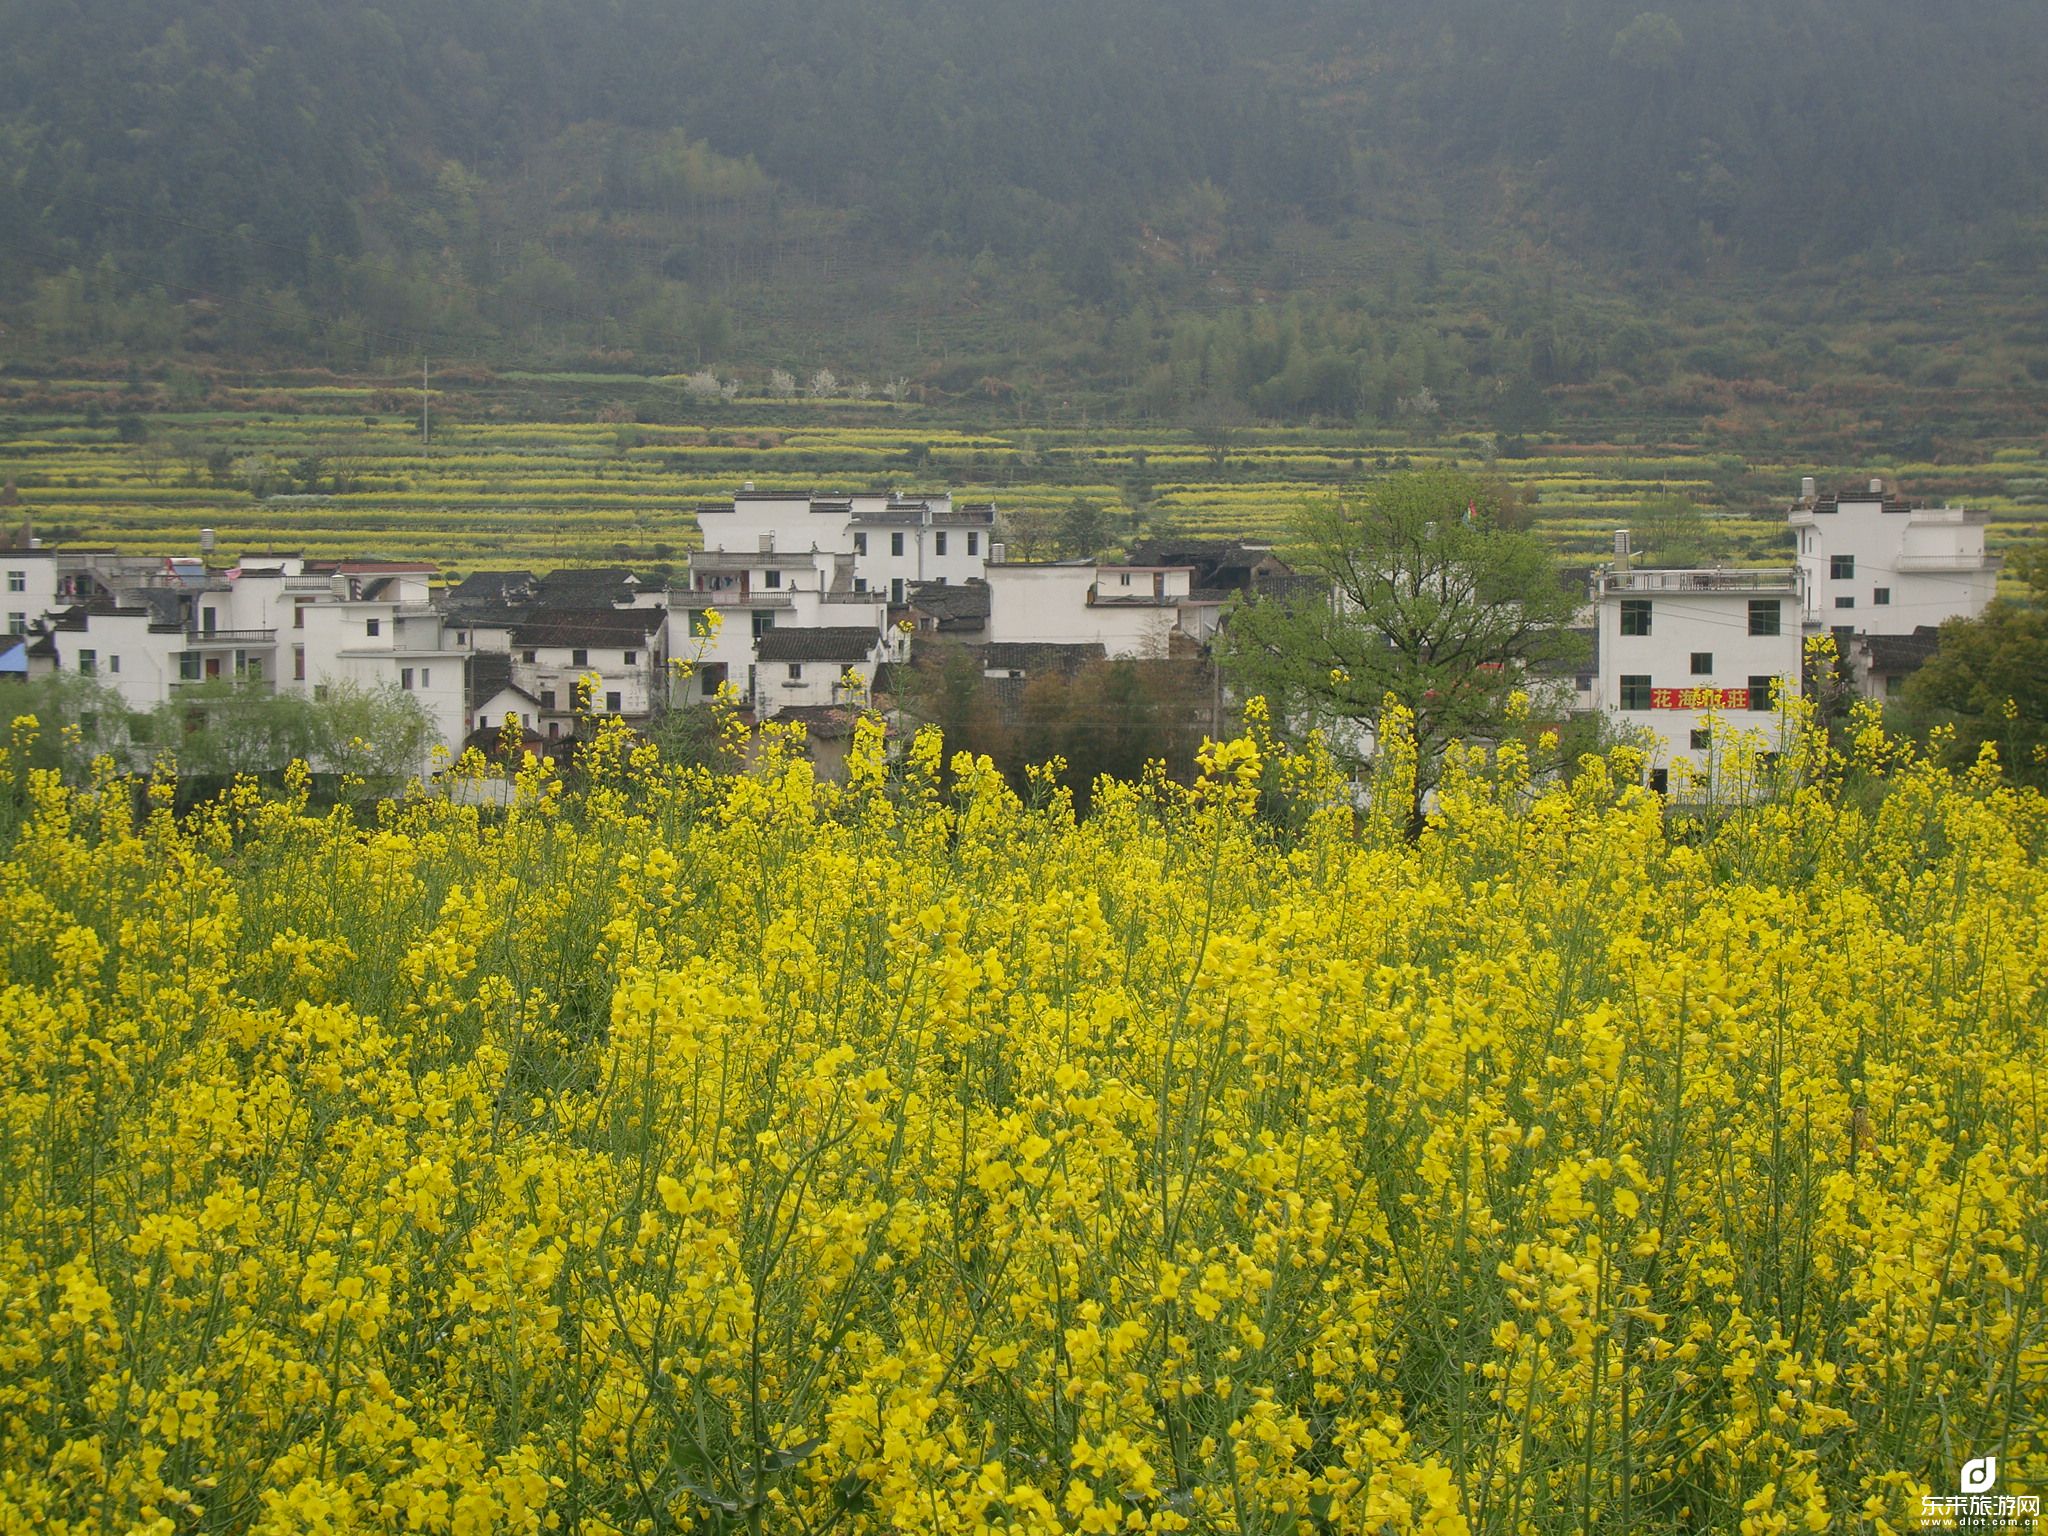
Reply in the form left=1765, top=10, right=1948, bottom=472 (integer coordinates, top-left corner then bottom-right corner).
left=1591, top=559, right=1802, bottom=788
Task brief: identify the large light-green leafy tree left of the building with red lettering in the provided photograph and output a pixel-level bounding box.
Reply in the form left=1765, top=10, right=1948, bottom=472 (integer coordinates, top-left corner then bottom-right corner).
left=1219, top=471, right=1583, bottom=831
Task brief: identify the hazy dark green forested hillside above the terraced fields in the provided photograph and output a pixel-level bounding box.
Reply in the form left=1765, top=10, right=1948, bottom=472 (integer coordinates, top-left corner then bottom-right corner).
left=0, top=0, right=2048, bottom=430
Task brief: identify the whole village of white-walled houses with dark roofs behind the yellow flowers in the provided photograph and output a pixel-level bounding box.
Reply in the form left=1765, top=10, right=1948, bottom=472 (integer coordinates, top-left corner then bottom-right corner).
left=0, top=477, right=1999, bottom=788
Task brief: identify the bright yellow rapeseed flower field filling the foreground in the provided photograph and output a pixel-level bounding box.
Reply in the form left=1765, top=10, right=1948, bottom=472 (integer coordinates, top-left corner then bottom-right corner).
left=0, top=719, right=2048, bottom=1536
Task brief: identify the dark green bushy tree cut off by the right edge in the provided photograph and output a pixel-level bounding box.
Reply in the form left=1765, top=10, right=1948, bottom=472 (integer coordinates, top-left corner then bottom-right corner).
left=1901, top=551, right=2048, bottom=786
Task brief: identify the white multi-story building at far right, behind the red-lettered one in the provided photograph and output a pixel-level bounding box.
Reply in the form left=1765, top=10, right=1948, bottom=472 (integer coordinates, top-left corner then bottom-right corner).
left=1788, top=475, right=2003, bottom=637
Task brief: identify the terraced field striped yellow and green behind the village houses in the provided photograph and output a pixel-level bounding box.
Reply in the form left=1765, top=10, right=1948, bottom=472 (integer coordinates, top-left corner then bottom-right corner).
left=0, top=385, right=2048, bottom=573
